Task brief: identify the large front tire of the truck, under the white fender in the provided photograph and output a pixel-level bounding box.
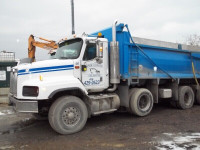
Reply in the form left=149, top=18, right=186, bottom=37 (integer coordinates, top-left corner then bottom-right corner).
left=48, top=96, right=88, bottom=134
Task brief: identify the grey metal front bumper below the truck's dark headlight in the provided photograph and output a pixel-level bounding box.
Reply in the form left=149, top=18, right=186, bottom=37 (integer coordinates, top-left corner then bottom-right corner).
left=9, top=95, right=38, bottom=113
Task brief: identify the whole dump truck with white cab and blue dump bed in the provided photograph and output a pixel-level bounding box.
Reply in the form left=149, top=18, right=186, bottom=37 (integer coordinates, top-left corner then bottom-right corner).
left=9, top=21, right=200, bottom=134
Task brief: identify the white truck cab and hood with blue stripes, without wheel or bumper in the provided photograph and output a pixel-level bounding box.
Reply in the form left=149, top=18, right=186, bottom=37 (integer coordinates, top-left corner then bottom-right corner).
left=11, top=36, right=109, bottom=100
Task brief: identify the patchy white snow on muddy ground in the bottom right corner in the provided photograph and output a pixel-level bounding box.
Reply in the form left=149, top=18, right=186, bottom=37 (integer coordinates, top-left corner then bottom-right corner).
left=156, top=133, right=200, bottom=150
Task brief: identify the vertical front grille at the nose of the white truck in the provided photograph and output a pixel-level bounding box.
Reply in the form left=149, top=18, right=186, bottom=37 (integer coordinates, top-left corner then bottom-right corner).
left=10, top=71, right=17, bottom=96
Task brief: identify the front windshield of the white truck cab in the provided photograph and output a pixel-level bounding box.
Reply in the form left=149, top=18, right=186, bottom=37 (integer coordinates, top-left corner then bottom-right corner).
left=55, top=38, right=83, bottom=59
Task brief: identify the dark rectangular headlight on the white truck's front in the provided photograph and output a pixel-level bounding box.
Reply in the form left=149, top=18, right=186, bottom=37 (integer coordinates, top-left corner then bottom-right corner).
left=22, top=86, right=39, bottom=97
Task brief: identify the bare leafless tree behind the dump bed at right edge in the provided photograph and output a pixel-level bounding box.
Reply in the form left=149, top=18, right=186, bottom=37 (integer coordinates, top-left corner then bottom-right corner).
left=185, top=34, right=200, bottom=46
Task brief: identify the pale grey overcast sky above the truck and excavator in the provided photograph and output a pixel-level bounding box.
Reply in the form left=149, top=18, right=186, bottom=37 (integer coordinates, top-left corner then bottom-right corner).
left=0, top=0, right=200, bottom=60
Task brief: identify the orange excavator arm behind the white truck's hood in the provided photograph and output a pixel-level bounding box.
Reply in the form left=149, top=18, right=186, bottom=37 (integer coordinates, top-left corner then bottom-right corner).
left=28, top=35, right=58, bottom=62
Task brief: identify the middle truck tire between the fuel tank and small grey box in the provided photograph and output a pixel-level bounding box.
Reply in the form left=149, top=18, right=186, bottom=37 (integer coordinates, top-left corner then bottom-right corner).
left=130, top=89, right=153, bottom=117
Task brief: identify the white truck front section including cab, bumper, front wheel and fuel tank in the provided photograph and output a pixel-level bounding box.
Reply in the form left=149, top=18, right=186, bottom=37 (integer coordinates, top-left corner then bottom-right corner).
left=10, top=32, right=120, bottom=134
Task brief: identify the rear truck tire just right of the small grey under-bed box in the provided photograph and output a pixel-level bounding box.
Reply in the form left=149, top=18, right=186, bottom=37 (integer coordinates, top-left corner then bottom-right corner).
left=177, top=86, right=194, bottom=109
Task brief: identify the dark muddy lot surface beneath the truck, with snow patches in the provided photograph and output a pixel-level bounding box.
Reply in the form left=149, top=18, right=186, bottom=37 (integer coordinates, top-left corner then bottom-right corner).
left=0, top=103, right=200, bottom=150
